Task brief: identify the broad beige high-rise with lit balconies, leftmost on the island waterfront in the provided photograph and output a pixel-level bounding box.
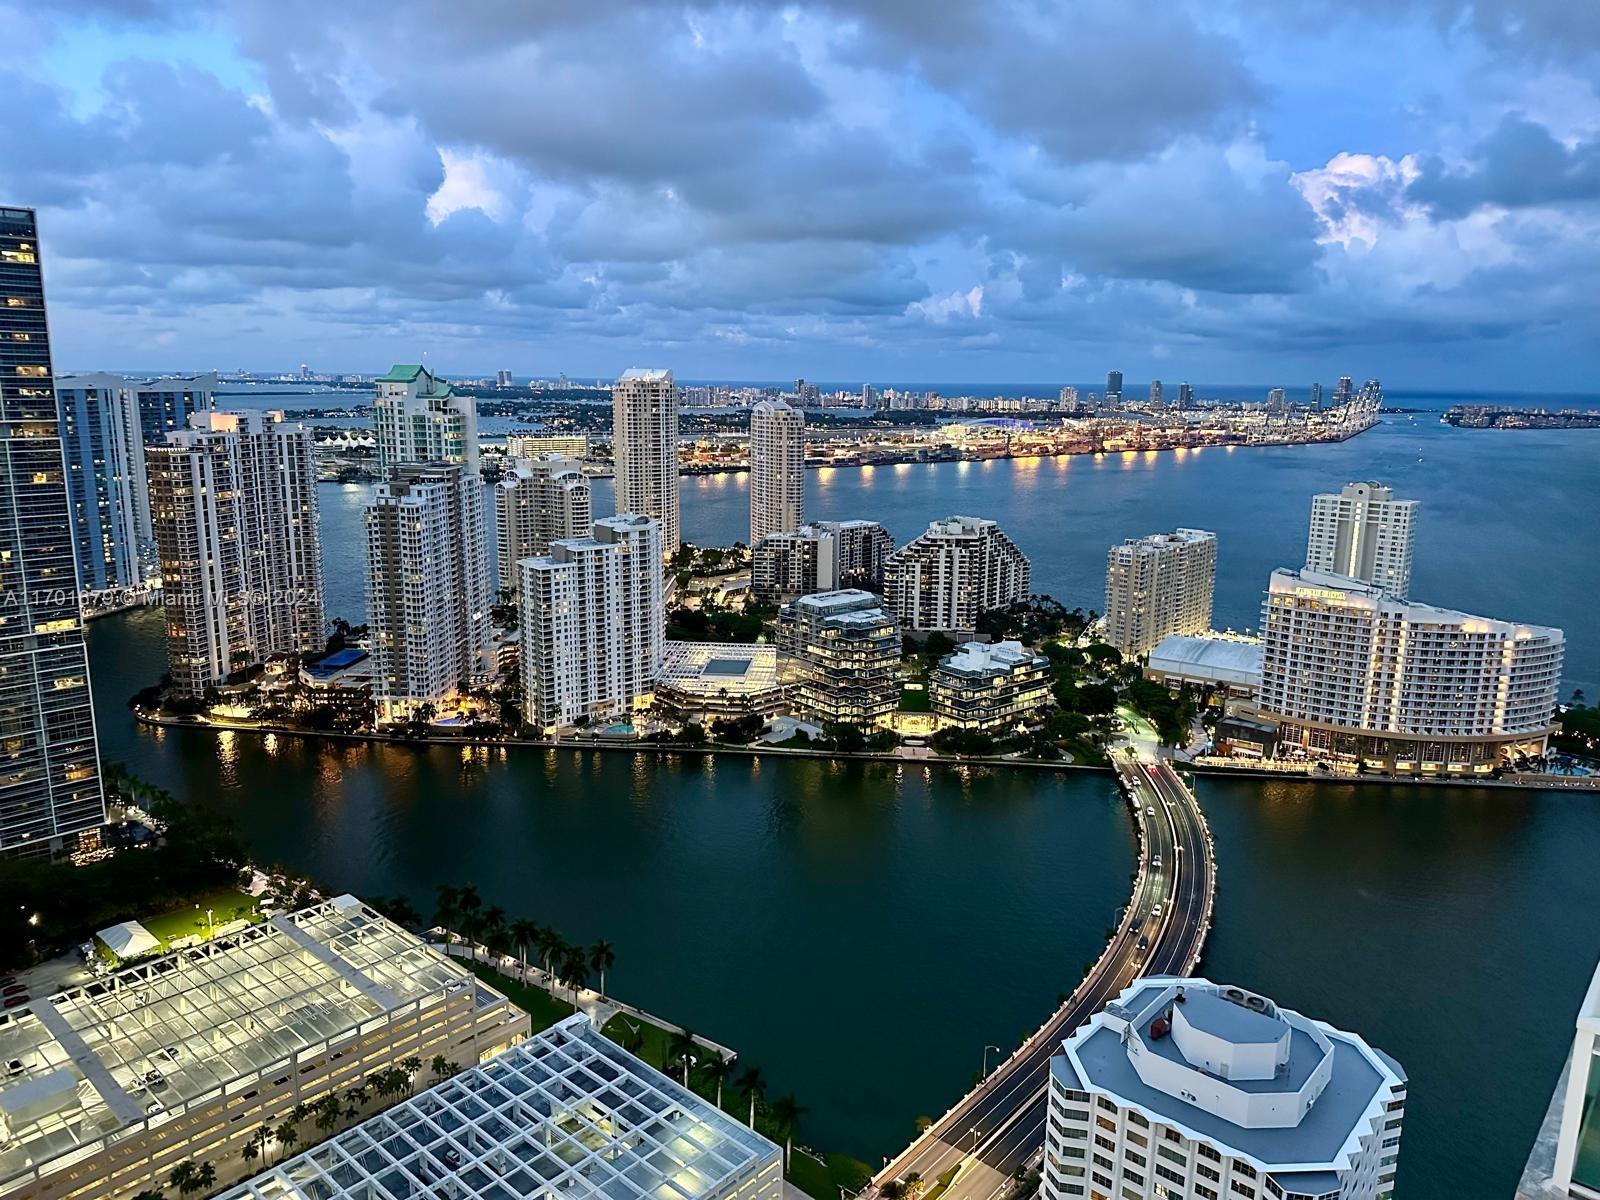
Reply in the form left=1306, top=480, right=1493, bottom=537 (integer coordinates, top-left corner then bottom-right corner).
left=146, top=411, right=325, bottom=696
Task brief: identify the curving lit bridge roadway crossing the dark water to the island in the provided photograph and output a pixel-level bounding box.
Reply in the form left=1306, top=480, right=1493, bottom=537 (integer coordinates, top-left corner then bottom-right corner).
left=872, top=761, right=1216, bottom=1200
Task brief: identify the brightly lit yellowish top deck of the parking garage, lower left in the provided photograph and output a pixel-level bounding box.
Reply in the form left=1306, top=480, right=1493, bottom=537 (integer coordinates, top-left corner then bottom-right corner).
left=0, top=896, right=499, bottom=1192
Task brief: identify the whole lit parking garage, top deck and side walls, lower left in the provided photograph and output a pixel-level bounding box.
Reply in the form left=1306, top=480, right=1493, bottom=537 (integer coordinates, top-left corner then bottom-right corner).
left=0, top=896, right=530, bottom=1200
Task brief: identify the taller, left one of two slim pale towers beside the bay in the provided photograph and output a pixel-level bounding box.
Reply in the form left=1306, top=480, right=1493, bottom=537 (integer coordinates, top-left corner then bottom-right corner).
left=611, top=366, right=678, bottom=558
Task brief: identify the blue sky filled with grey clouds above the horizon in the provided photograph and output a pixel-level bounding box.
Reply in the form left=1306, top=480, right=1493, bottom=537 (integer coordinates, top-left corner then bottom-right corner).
left=12, top=0, right=1600, bottom=390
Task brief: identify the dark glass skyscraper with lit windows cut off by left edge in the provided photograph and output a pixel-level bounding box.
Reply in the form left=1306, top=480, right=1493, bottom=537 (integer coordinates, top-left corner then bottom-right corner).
left=0, top=208, right=106, bottom=856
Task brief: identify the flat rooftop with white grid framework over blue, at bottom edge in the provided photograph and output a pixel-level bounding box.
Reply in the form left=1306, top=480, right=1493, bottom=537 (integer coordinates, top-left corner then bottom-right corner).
left=222, top=1014, right=781, bottom=1200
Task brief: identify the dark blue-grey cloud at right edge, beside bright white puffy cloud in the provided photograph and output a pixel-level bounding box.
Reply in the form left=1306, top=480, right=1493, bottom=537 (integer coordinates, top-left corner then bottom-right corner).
left=1410, top=114, right=1600, bottom=218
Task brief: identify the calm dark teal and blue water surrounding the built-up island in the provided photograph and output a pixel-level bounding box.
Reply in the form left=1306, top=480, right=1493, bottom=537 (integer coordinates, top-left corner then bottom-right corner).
left=90, top=406, right=1600, bottom=1200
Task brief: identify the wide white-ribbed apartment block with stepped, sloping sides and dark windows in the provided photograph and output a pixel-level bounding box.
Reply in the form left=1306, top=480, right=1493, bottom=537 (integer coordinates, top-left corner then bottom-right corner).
left=883, top=517, right=1032, bottom=634
